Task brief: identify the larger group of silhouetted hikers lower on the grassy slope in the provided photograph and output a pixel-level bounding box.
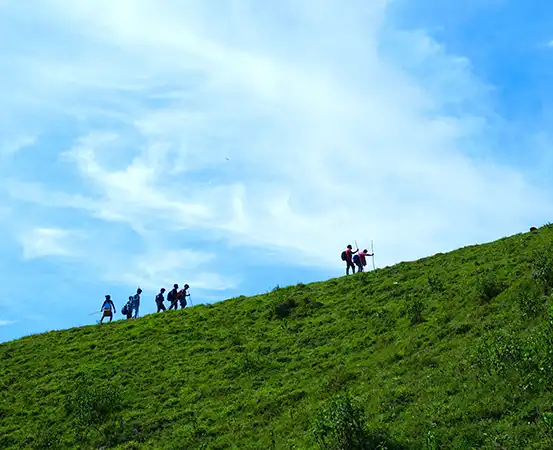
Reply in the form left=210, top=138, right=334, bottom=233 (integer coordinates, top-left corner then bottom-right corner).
left=100, top=284, right=190, bottom=323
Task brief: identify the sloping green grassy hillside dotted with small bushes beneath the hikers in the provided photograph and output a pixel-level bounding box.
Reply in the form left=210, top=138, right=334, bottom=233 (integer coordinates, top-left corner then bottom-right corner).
left=0, top=226, right=553, bottom=449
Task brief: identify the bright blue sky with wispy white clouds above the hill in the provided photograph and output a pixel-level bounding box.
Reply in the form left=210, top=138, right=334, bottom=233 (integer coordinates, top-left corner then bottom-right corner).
left=0, top=0, right=553, bottom=341
